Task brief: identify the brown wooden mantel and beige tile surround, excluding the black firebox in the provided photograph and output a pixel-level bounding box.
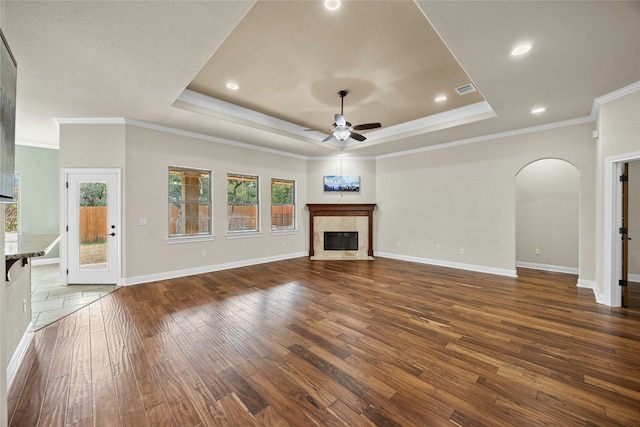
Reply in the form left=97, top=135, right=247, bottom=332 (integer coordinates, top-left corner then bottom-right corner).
left=307, top=203, right=376, bottom=260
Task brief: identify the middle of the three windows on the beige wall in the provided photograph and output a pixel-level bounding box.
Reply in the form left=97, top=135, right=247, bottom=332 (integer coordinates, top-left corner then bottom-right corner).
left=227, top=174, right=259, bottom=233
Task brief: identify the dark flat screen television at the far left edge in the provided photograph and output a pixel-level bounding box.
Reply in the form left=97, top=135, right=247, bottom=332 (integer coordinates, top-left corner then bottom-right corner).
left=0, top=29, right=18, bottom=202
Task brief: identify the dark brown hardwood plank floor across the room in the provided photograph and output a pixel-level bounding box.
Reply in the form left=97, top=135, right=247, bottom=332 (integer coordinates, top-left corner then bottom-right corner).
left=9, top=258, right=640, bottom=427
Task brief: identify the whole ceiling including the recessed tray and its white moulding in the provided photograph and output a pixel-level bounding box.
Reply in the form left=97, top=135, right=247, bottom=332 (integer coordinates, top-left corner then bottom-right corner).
left=0, top=0, right=640, bottom=156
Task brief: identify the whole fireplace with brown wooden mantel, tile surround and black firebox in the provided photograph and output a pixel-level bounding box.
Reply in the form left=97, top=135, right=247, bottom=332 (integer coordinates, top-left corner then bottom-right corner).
left=307, top=203, right=376, bottom=260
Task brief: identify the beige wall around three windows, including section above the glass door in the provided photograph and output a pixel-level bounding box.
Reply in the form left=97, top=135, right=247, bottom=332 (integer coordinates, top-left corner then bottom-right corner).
left=60, top=122, right=308, bottom=284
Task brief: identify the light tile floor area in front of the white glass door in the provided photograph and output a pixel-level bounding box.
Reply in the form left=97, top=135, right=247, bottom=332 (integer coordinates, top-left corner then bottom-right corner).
left=31, top=264, right=116, bottom=331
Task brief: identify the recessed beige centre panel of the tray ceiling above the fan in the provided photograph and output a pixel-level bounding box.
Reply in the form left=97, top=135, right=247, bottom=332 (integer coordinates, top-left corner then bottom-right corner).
left=188, top=1, right=483, bottom=129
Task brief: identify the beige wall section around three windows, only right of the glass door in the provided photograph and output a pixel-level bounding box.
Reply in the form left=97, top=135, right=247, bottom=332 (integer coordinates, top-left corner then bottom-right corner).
left=124, top=126, right=308, bottom=278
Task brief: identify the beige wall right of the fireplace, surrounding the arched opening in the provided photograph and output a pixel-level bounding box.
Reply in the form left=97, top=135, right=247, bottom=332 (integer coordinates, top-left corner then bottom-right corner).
left=374, top=123, right=595, bottom=280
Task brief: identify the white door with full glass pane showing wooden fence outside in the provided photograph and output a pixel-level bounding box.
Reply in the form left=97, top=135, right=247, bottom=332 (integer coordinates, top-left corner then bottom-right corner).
left=65, top=170, right=120, bottom=284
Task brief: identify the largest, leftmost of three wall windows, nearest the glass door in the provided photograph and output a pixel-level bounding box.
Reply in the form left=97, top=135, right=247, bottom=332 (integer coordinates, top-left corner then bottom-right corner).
left=169, top=167, right=213, bottom=237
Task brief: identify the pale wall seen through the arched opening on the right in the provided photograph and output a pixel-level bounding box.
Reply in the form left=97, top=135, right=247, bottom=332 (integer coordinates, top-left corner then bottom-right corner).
left=516, top=159, right=580, bottom=272
